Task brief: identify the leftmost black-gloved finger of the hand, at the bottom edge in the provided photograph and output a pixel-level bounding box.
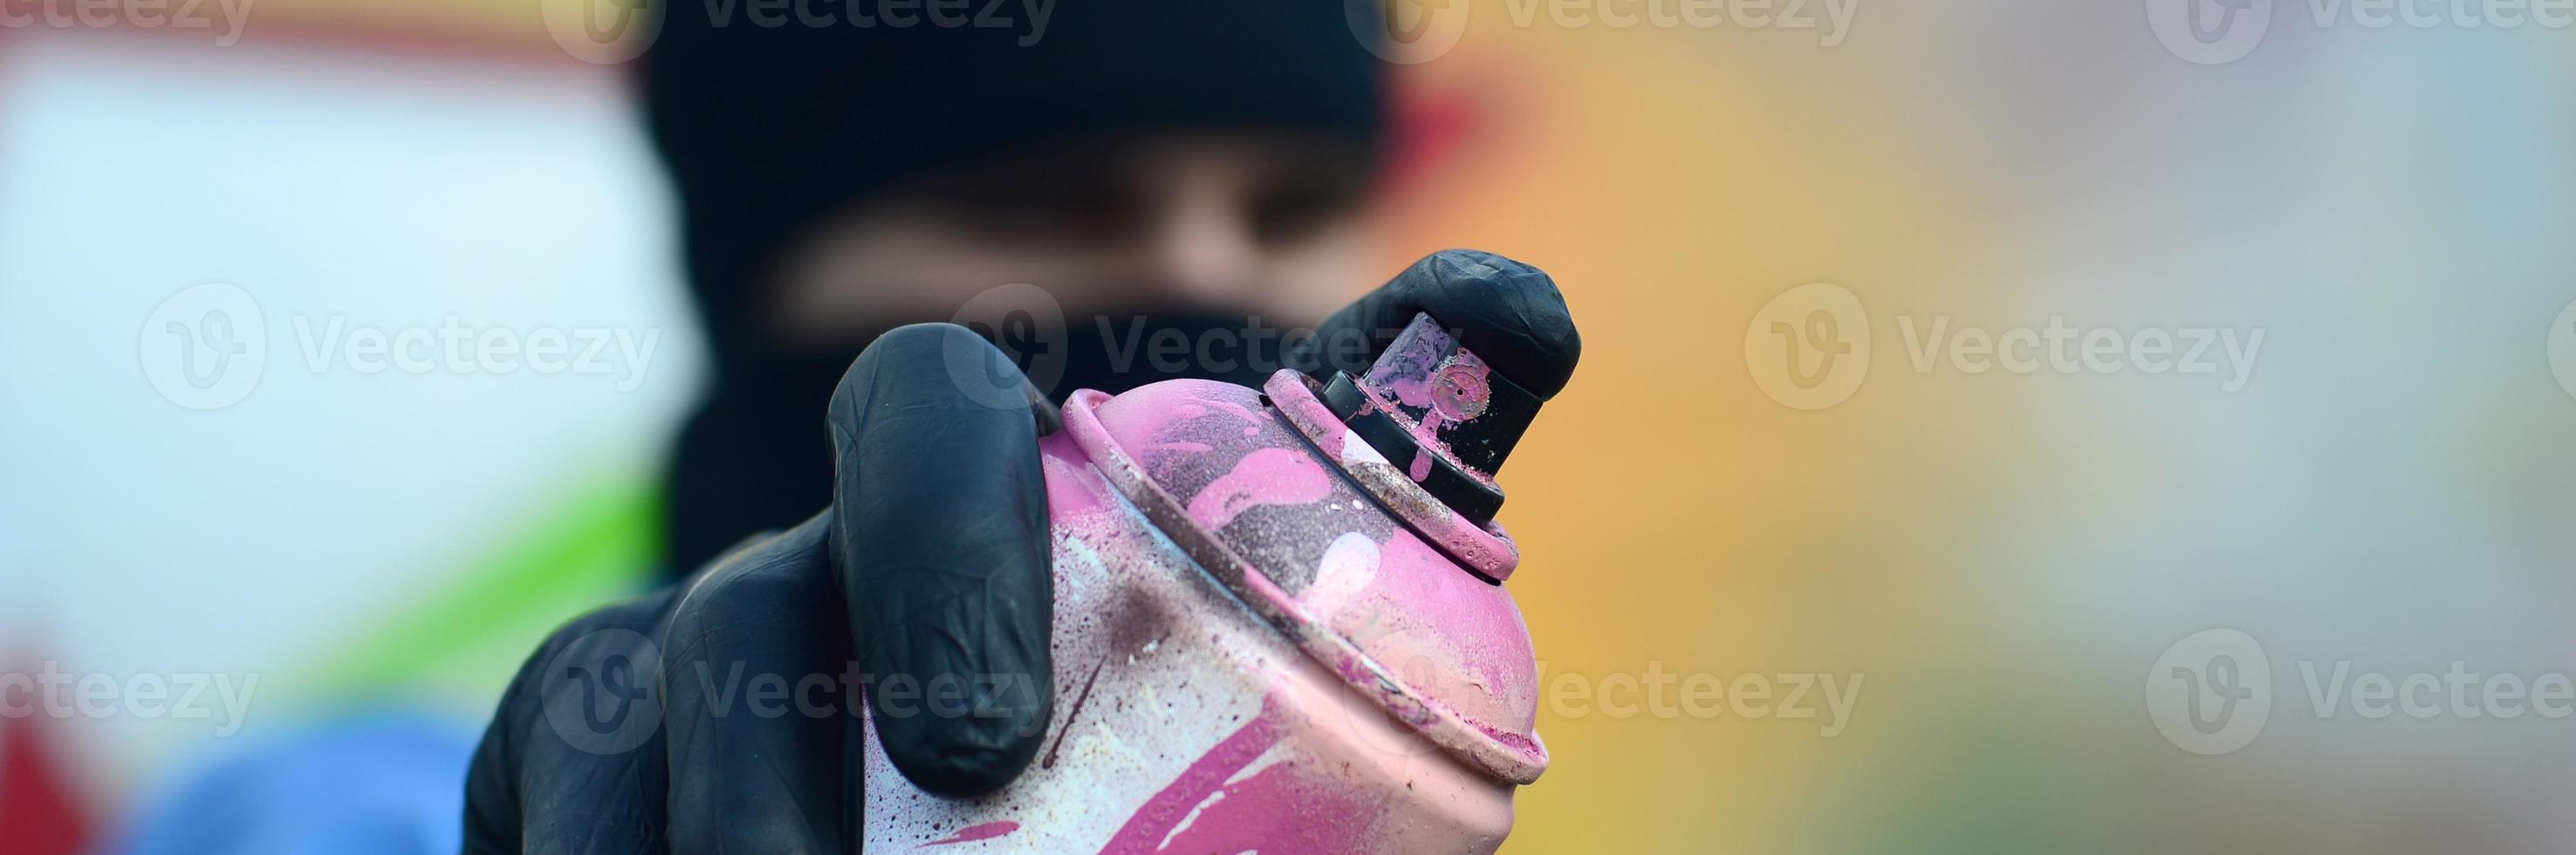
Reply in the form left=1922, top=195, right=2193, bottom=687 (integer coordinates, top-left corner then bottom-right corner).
left=463, top=590, right=675, bottom=852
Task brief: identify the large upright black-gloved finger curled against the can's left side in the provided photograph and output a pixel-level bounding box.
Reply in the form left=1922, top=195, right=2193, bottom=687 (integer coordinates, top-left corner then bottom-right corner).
left=830, top=325, right=1056, bottom=796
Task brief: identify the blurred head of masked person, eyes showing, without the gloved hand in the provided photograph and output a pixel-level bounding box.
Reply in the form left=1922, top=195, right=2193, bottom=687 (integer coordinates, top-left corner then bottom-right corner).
left=644, top=3, right=1383, bottom=569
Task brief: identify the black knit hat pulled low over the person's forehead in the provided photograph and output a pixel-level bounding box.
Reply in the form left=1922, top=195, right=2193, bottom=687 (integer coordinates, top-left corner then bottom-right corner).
left=644, top=0, right=1383, bottom=371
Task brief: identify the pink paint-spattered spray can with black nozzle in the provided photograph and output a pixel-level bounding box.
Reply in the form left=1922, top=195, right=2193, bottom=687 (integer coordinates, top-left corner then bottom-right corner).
left=866, top=314, right=1548, bottom=855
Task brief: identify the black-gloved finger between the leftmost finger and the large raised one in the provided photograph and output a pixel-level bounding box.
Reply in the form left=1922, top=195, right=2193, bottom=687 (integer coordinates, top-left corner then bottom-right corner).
left=662, top=515, right=858, bottom=852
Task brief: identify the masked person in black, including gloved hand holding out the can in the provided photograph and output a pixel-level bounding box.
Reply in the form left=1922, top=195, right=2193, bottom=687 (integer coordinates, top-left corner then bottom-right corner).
left=466, top=0, right=1579, bottom=852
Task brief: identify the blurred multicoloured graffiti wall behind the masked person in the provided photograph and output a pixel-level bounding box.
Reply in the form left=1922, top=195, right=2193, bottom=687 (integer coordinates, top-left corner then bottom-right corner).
left=0, top=0, right=2576, bottom=852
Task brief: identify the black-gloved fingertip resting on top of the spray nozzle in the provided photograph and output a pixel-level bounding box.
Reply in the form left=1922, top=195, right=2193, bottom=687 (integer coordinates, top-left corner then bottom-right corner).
left=1293, top=250, right=1584, bottom=401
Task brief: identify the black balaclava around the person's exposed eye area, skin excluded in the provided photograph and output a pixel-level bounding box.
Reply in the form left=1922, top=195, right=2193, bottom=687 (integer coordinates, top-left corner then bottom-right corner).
left=644, top=0, right=1383, bottom=571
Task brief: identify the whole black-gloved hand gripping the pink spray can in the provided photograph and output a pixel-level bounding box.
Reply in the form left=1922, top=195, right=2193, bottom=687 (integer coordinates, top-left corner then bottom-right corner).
left=466, top=250, right=1582, bottom=852
